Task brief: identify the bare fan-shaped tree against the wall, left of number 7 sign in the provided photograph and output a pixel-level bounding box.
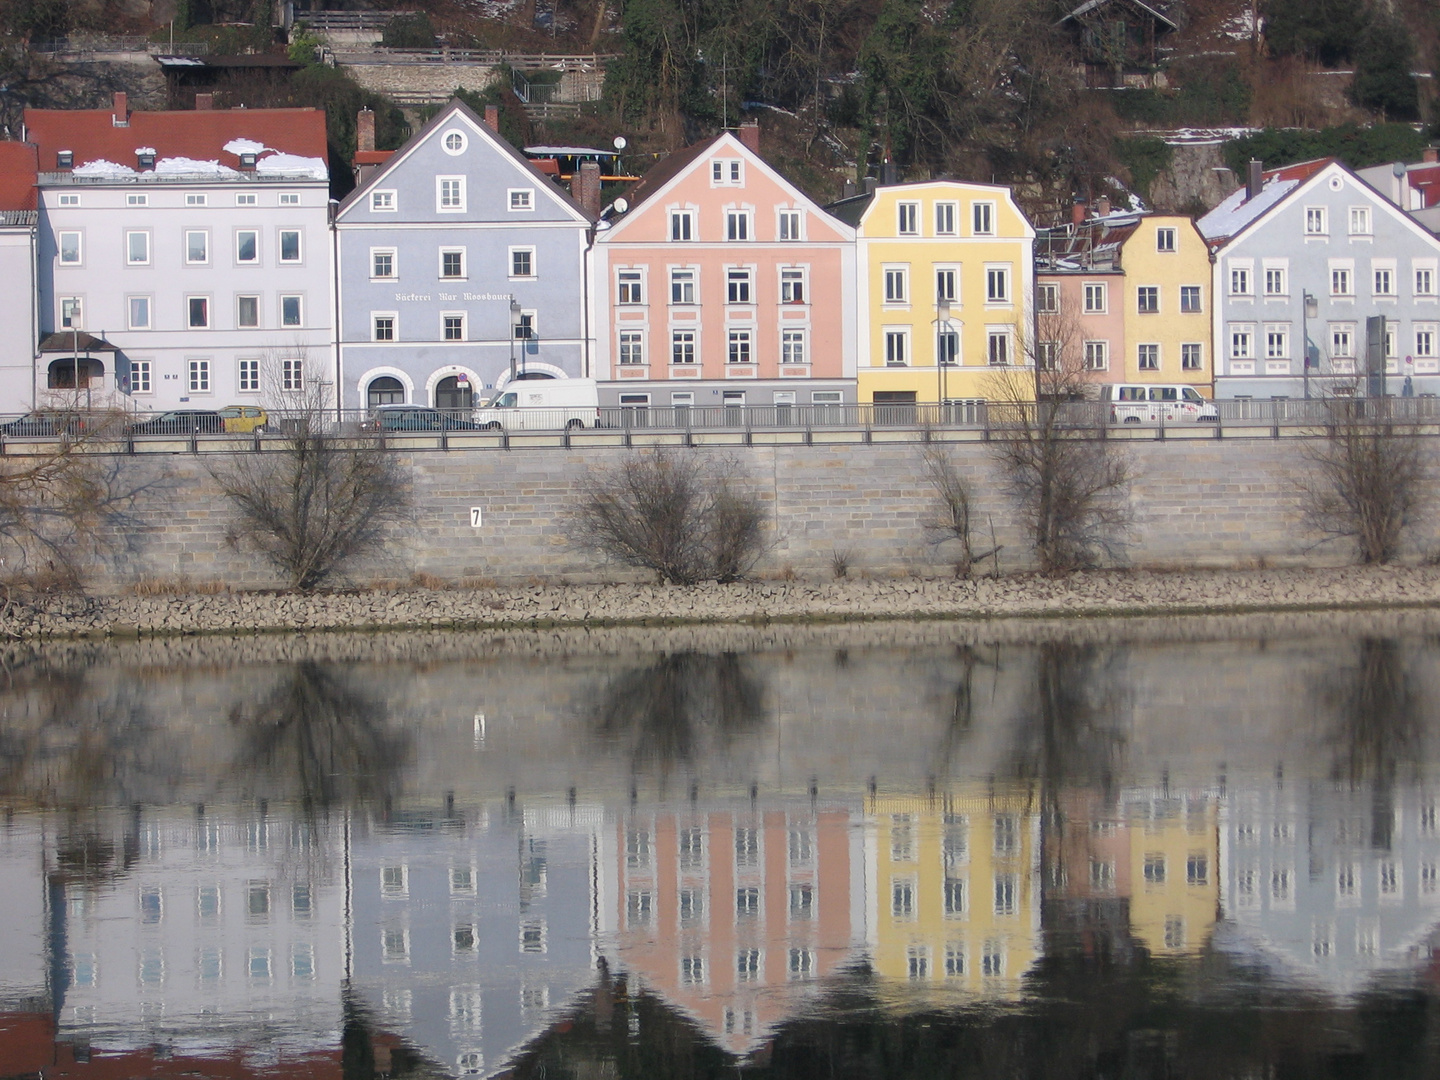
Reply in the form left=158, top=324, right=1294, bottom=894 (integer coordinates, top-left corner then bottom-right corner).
left=210, top=348, right=410, bottom=590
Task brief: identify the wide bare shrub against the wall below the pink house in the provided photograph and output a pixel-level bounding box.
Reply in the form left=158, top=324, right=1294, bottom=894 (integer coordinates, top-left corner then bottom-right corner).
left=567, top=449, right=765, bottom=585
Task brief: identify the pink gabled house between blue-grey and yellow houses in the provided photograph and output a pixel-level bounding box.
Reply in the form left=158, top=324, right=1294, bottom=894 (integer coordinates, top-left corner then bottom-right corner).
left=590, top=124, right=855, bottom=409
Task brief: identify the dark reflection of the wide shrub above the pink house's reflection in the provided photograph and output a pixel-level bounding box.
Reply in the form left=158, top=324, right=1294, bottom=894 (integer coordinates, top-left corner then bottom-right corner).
left=593, top=652, right=765, bottom=772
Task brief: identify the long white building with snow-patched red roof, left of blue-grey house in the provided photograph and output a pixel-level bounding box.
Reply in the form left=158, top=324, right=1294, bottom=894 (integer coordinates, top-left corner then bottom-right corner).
left=24, top=94, right=334, bottom=410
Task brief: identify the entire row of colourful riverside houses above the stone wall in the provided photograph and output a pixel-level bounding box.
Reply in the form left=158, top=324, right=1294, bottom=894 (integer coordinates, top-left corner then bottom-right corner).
left=0, top=94, right=1440, bottom=412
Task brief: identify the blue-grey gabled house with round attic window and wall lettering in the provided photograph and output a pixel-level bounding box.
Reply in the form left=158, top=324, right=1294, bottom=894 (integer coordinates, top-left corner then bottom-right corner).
left=336, top=101, right=593, bottom=410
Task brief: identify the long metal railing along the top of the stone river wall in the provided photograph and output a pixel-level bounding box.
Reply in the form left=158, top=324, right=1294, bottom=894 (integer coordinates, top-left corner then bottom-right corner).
left=0, top=397, right=1440, bottom=454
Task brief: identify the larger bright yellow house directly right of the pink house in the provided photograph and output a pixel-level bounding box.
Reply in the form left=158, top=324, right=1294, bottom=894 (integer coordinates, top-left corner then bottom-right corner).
left=828, top=180, right=1035, bottom=406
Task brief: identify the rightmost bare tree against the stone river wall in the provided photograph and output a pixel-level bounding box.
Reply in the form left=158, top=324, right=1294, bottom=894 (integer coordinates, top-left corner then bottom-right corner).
left=1300, top=397, right=1430, bottom=563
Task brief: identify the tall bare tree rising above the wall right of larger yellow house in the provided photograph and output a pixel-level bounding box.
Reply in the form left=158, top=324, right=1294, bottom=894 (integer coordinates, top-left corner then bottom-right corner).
left=988, top=300, right=1132, bottom=573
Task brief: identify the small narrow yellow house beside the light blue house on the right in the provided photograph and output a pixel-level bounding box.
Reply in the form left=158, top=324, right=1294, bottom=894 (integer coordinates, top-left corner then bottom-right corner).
left=1107, top=215, right=1214, bottom=397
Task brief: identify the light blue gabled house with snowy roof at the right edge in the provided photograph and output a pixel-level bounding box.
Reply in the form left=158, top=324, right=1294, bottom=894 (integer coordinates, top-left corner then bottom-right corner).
left=1197, top=158, right=1440, bottom=399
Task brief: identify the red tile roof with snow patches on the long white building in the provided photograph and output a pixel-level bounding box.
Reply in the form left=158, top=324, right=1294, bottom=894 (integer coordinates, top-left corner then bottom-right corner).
left=24, top=99, right=327, bottom=173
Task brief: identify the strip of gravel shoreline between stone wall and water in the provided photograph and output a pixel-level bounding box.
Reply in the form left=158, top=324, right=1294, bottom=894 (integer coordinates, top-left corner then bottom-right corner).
left=8, top=566, right=1440, bottom=639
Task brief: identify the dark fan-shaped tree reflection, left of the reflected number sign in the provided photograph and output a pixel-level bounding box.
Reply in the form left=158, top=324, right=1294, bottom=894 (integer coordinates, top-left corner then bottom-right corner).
left=230, top=661, right=410, bottom=815
